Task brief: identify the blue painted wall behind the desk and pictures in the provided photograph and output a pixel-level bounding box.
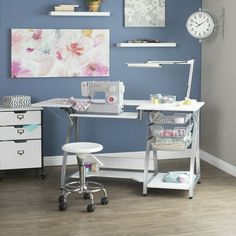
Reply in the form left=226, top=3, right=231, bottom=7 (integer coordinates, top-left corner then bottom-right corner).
left=0, top=0, right=201, bottom=155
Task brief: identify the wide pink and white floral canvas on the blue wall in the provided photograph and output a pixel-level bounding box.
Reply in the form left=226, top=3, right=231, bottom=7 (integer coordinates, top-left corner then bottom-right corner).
left=11, top=29, right=110, bottom=78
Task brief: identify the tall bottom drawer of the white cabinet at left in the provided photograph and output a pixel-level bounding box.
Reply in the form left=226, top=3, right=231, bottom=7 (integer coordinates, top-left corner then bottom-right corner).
left=0, top=140, right=41, bottom=170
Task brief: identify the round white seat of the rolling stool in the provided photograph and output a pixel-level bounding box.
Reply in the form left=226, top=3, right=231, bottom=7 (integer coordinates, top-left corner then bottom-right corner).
left=62, top=142, right=103, bottom=154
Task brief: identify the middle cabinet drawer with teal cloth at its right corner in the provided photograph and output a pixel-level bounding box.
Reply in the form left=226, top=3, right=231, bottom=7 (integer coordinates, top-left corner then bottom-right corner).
left=0, top=125, right=41, bottom=141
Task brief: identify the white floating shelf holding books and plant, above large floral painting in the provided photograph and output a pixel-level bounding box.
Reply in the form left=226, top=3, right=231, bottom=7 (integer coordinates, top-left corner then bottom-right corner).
left=49, top=11, right=110, bottom=16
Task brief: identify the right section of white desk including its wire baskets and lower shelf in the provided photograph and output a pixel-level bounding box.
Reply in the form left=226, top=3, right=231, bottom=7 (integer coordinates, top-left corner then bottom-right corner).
left=137, top=102, right=204, bottom=198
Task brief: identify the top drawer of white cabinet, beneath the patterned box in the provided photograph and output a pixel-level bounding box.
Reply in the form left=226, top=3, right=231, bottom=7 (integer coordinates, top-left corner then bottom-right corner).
left=0, top=111, right=41, bottom=126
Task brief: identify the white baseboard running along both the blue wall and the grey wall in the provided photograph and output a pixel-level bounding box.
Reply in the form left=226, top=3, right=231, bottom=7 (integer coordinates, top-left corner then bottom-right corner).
left=44, top=150, right=236, bottom=177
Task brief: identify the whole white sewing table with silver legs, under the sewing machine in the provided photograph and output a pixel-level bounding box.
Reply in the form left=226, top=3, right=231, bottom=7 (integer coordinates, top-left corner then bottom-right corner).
left=33, top=98, right=204, bottom=197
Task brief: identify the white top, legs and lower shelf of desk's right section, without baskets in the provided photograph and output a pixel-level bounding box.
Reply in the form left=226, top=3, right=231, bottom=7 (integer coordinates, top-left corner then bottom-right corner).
left=137, top=102, right=204, bottom=199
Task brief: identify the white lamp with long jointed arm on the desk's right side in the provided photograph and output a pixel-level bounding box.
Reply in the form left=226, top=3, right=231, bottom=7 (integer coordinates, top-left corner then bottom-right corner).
left=126, top=59, right=195, bottom=99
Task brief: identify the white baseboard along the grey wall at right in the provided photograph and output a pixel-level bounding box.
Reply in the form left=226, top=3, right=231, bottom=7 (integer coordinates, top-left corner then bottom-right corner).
left=200, top=150, right=236, bottom=177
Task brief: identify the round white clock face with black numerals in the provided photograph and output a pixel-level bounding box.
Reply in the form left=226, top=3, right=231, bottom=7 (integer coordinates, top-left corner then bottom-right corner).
left=186, top=11, right=215, bottom=39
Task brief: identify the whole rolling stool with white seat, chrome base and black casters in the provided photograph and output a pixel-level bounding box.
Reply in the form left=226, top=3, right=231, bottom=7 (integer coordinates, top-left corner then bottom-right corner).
left=59, top=142, right=109, bottom=212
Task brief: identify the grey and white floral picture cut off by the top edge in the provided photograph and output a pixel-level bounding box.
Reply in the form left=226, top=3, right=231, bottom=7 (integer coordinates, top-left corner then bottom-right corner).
left=125, top=0, right=165, bottom=27
